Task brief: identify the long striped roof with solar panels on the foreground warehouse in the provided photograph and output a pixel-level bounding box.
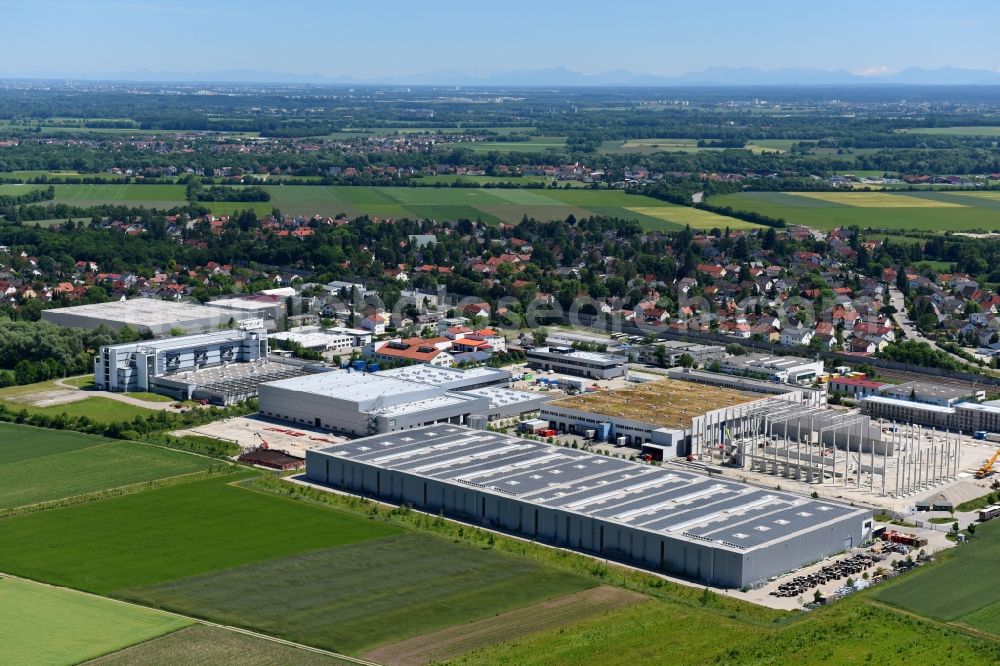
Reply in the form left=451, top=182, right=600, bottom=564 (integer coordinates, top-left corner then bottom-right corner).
left=321, top=424, right=866, bottom=552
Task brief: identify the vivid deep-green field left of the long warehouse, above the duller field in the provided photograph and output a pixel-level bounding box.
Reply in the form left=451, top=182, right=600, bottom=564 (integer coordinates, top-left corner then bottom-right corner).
left=0, top=472, right=398, bottom=594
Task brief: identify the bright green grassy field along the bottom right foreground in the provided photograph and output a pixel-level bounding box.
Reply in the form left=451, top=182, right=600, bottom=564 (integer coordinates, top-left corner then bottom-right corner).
left=448, top=597, right=1000, bottom=666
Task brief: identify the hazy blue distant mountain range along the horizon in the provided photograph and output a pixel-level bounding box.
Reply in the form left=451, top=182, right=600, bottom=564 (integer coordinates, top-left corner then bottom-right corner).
left=0, top=66, right=1000, bottom=87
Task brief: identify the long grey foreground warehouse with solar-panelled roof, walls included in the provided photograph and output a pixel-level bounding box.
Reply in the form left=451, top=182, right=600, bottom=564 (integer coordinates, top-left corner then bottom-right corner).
left=306, top=424, right=872, bottom=588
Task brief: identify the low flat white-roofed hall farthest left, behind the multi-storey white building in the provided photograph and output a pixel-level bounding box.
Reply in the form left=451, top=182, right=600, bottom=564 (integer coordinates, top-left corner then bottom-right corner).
left=42, top=298, right=255, bottom=337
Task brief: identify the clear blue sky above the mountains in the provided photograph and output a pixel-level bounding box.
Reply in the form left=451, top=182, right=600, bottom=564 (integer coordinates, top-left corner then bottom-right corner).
left=0, top=0, right=1000, bottom=79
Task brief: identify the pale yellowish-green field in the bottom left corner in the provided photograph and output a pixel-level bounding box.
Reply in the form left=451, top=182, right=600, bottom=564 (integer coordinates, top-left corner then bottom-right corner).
left=0, top=576, right=191, bottom=666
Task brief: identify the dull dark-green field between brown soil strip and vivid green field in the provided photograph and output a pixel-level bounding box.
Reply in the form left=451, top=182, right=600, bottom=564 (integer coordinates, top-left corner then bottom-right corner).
left=125, top=534, right=594, bottom=653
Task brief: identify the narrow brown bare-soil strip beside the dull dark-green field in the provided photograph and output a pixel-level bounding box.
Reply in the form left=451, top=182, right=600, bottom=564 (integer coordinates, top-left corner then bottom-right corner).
left=363, top=586, right=647, bottom=666
